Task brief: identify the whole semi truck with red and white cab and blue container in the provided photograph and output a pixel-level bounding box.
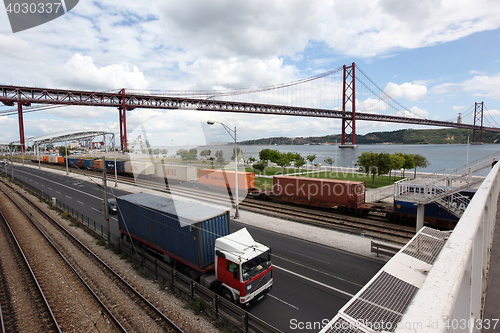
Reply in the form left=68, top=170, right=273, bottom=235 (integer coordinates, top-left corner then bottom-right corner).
left=116, top=193, right=273, bottom=305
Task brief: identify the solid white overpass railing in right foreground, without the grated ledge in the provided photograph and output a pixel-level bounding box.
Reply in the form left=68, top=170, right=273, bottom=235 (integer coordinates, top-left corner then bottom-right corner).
left=396, top=163, right=500, bottom=333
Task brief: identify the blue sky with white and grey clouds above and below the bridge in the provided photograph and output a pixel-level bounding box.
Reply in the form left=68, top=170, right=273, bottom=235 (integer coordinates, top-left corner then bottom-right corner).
left=0, top=0, right=500, bottom=144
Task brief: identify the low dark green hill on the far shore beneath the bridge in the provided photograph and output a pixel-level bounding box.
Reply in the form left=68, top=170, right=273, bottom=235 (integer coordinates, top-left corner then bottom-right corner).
left=239, top=128, right=500, bottom=145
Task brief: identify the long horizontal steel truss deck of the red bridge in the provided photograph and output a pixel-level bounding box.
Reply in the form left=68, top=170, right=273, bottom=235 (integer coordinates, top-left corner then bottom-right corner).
left=0, top=85, right=500, bottom=149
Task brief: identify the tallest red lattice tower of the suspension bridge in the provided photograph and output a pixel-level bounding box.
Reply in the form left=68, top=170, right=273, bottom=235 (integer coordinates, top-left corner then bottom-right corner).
left=339, top=62, right=358, bottom=148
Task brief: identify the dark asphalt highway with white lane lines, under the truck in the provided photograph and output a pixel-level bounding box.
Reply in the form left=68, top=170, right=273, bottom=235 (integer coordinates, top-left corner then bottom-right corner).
left=3, top=165, right=383, bottom=332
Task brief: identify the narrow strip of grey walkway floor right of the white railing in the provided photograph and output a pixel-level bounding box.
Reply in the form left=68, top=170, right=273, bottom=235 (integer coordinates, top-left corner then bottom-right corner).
left=483, top=197, right=500, bottom=332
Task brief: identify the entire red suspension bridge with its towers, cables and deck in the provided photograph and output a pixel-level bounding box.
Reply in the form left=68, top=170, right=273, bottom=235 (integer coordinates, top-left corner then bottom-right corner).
left=0, top=63, right=500, bottom=150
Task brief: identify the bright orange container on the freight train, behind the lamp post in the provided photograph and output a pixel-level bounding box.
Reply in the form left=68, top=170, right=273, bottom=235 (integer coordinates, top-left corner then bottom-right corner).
left=198, top=169, right=255, bottom=190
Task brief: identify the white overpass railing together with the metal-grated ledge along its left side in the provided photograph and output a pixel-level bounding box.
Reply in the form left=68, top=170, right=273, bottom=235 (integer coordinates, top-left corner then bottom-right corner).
left=321, top=163, right=500, bottom=333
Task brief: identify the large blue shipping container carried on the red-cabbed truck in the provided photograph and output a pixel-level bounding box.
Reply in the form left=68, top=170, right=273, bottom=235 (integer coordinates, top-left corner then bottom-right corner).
left=117, top=193, right=229, bottom=271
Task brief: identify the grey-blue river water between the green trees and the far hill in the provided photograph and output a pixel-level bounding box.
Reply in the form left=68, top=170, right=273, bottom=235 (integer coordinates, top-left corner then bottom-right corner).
left=198, top=144, right=500, bottom=173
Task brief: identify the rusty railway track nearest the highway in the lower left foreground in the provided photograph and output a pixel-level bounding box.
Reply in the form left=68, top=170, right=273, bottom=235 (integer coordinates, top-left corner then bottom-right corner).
left=2, top=179, right=186, bottom=332
